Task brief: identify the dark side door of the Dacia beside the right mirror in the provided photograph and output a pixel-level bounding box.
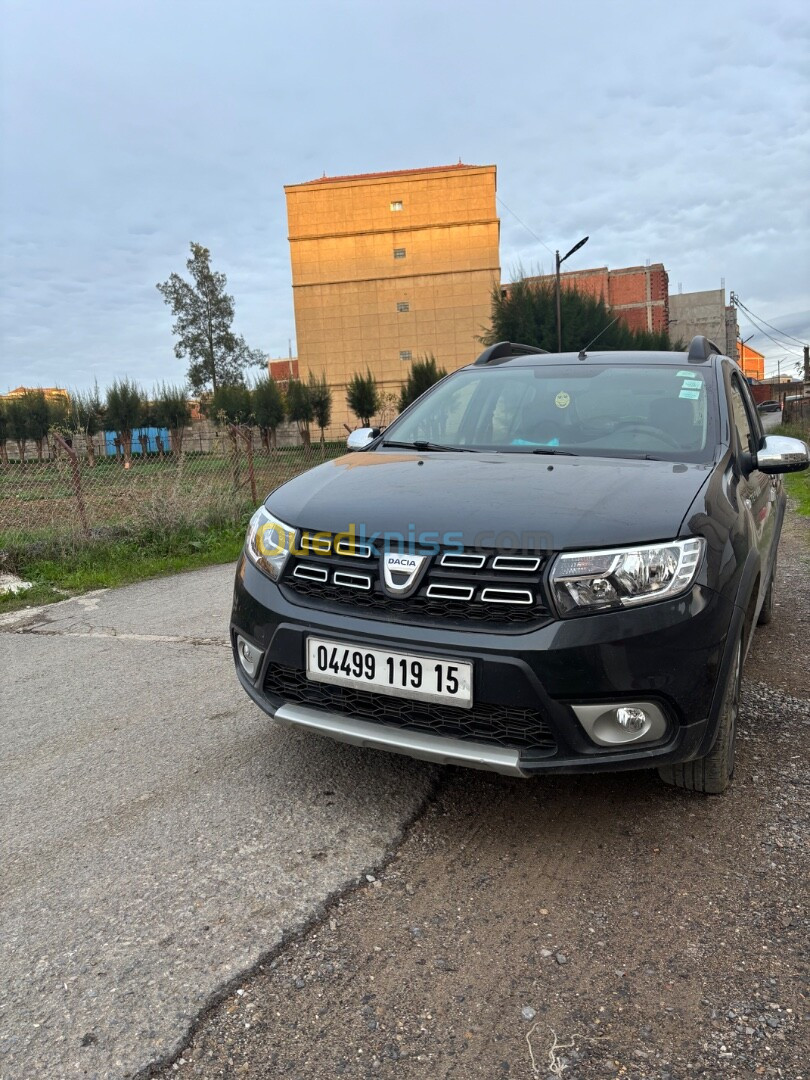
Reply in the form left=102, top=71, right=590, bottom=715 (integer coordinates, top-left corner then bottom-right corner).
left=729, top=373, right=779, bottom=589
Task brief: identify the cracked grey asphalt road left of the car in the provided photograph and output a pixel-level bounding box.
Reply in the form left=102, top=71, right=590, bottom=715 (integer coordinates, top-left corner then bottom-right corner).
left=0, top=567, right=434, bottom=1080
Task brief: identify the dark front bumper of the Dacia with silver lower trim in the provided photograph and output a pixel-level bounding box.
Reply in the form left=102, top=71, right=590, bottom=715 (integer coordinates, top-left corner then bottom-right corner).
left=231, top=556, right=735, bottom=775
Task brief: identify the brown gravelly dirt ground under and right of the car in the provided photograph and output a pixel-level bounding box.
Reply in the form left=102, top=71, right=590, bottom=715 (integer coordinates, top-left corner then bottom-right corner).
left=149, top=518, right=810, bottom=1080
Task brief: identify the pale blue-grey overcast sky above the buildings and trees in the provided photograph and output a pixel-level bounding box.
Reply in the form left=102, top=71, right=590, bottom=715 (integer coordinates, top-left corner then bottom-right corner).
left=0, top=0, right=810, bottom=392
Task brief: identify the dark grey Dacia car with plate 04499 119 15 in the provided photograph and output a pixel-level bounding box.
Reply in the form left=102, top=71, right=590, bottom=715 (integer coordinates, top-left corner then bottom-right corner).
left=231, top=337, right=808, bottom=793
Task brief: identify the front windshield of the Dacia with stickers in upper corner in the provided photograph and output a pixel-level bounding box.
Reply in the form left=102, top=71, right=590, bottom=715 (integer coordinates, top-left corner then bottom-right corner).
left=381, top=361, right=716, bottom=462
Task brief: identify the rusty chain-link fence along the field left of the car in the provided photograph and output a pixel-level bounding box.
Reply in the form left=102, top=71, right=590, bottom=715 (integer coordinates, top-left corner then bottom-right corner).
left=0, top=438, right=346, bottom=554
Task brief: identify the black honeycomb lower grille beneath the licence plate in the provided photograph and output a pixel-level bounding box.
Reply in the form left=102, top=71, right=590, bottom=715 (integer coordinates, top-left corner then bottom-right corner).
left=265, top=664, right=556, bottom=757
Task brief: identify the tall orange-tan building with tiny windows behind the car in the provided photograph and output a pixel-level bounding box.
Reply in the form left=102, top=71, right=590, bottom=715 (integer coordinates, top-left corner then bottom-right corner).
left=284, top=163, right=500, bottom=431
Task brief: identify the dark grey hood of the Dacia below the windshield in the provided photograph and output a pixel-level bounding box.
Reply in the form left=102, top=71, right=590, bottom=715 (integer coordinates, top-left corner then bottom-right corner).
left=267, top=451, right=711, bottom=551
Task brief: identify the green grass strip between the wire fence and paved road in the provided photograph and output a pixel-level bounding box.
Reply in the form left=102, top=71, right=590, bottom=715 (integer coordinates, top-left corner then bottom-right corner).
left=0, top=522, right=245, bottom=612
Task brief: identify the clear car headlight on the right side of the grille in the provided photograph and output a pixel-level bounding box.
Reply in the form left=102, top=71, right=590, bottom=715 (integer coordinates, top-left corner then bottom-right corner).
left=551, top=537, right=705, bottom=615
